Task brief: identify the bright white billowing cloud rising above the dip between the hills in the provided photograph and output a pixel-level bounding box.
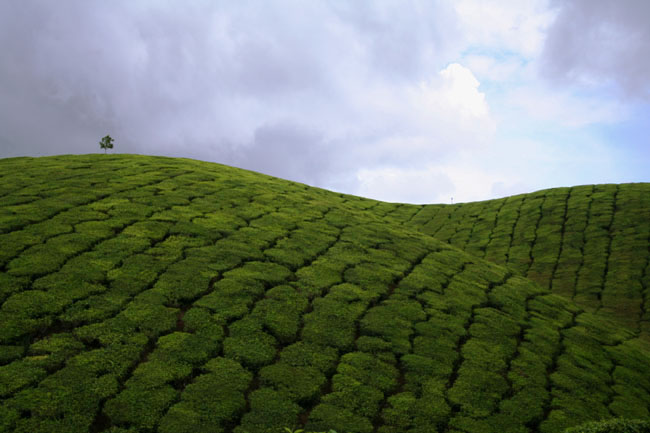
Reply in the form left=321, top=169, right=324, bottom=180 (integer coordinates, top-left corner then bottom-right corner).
left=344, top=63, right=498, bottom=203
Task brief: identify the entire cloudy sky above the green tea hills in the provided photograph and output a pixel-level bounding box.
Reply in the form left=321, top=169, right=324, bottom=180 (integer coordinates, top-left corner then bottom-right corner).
left=0, top=0, right=650, bottom=203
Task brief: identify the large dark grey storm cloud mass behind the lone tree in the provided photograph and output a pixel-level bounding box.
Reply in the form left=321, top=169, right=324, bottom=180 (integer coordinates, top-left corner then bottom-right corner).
left=0, top=0, right=456, bottom=188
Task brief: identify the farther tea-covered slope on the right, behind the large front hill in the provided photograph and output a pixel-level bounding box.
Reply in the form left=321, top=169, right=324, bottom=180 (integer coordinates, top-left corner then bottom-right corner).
left=389, top=183, right=650, bottom=341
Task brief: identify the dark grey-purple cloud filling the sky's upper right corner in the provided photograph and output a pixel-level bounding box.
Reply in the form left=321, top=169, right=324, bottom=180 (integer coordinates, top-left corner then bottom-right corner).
left=542, top=0, right=650, bottom=99
